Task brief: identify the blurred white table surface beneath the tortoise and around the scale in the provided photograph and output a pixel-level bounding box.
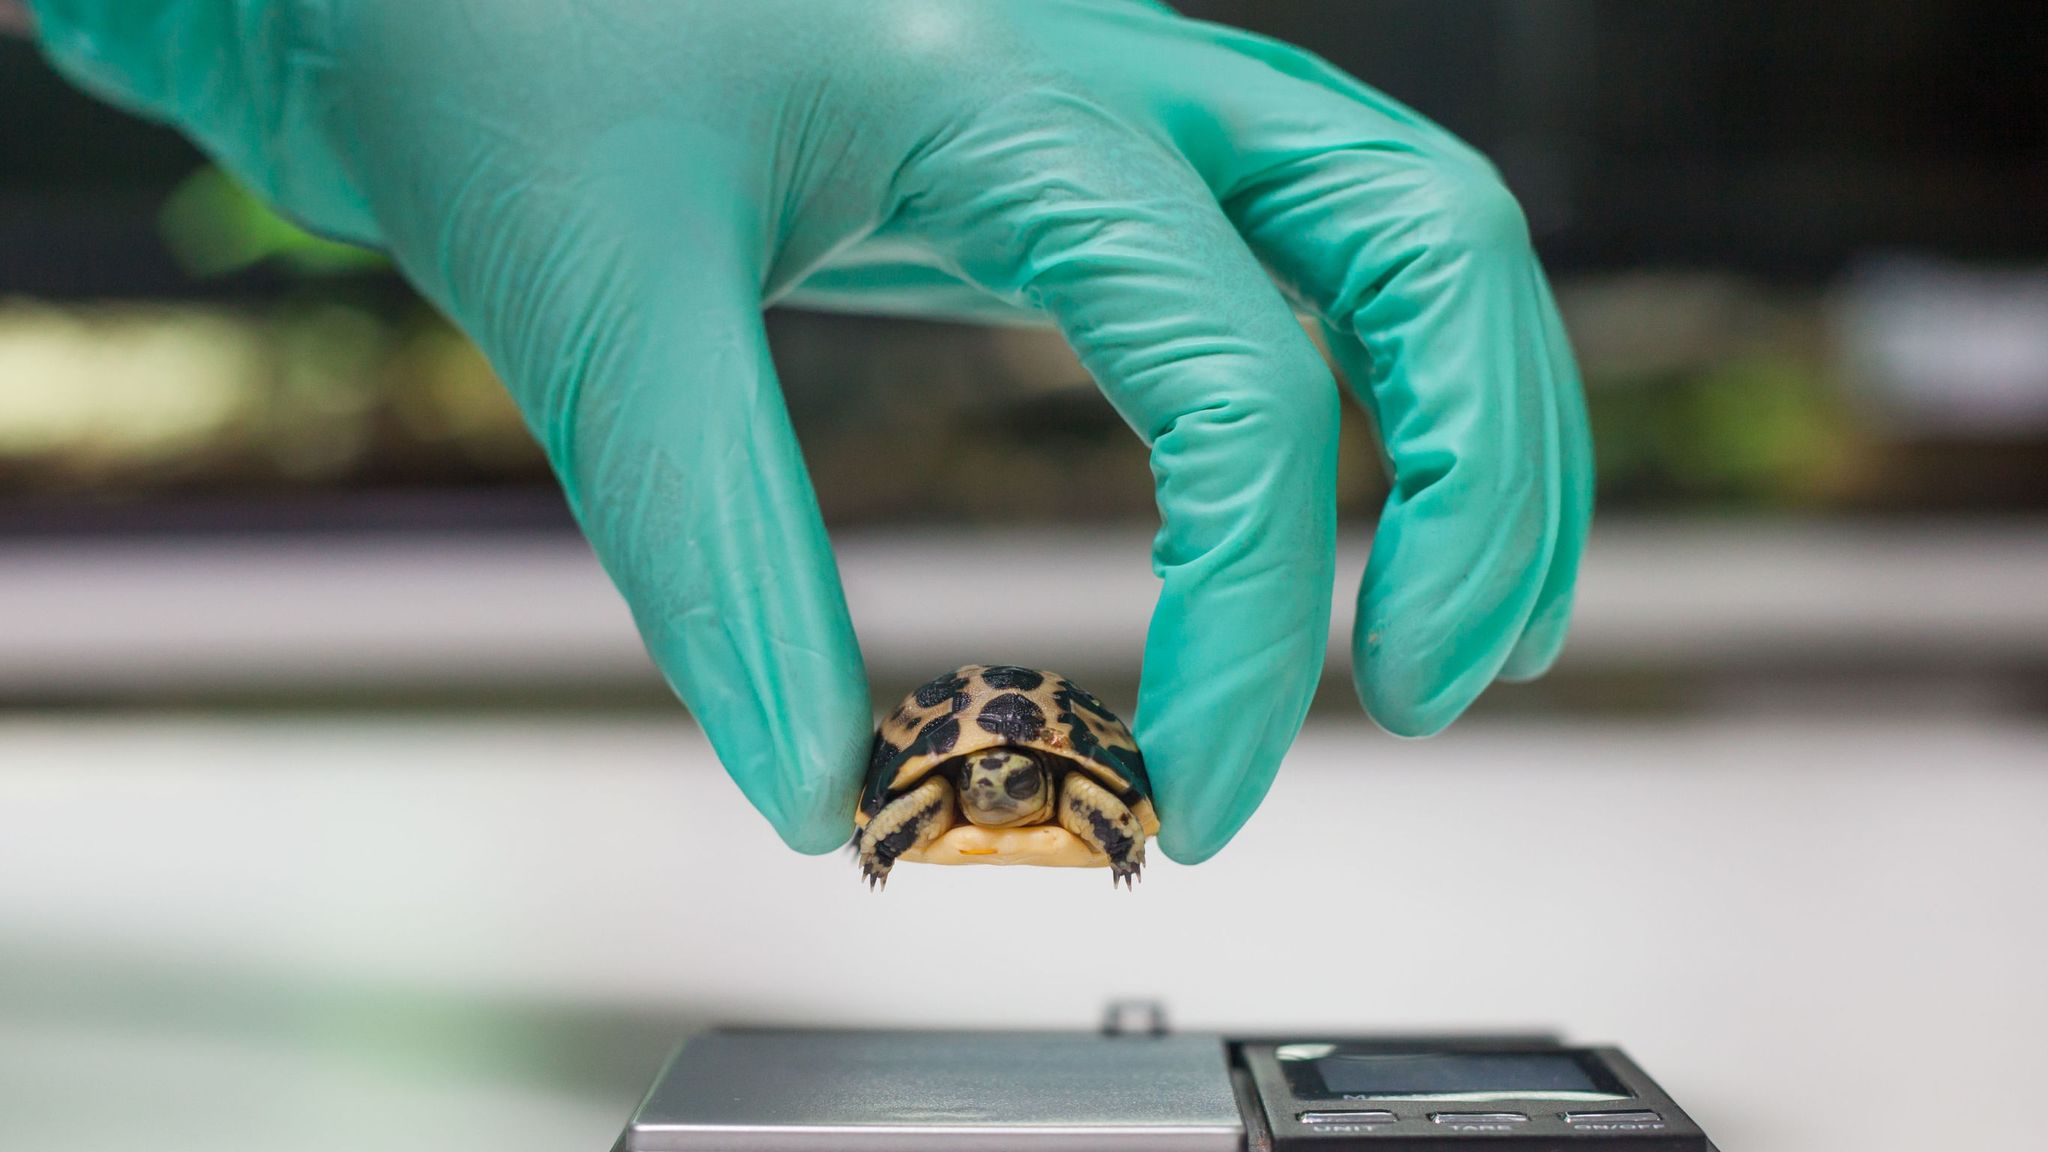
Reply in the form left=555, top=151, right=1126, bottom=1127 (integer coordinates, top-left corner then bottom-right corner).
left=0, top=713, right=2048, bottom=1152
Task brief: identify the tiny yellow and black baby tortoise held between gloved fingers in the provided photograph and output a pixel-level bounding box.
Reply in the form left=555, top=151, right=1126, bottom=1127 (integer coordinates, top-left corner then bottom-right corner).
left=854, top=664, right=1159, bottom=888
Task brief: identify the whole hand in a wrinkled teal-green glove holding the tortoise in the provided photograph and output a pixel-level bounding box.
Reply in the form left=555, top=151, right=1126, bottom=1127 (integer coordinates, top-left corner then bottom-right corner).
left=33, top=0, right=1589, bottom=861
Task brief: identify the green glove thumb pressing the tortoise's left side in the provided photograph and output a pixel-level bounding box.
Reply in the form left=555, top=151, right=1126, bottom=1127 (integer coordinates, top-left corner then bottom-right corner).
left=571, top=272, right=872, bottom=853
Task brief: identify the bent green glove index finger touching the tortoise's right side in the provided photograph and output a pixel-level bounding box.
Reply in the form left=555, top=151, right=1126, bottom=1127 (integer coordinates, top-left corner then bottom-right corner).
left=905, top=90, right=1337, bottom=863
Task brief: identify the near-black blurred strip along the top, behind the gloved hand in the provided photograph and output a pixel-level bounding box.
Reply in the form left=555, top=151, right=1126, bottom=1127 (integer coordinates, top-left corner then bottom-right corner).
left=0, top=0, right=2048, bottom=286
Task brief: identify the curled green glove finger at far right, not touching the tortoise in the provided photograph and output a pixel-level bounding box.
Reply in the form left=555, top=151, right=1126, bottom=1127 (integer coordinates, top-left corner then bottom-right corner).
left=1227, top=132, right=1589, bottom=736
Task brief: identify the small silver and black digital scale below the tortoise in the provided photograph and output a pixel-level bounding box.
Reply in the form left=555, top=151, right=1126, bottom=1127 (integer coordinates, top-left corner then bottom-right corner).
left=614, top=1013, right=1712, bottom=1152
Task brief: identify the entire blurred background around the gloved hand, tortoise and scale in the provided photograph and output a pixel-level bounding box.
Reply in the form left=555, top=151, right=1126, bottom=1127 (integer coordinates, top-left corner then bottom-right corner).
left=0, top=0, right=2048, bottom=1150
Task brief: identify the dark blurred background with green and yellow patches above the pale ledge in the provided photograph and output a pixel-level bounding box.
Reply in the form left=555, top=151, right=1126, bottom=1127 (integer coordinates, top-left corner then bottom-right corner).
left=0, top=0, right=2048, bottom=533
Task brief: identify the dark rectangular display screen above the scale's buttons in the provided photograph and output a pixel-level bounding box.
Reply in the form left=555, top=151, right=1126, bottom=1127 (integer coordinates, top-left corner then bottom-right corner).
left=1276, top=1043, right=1630, bottom=1101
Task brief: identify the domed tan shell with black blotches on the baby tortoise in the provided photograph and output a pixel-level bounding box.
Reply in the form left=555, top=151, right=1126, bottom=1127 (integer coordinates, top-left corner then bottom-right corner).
left=854, top=664, right=1157, bottom=826
